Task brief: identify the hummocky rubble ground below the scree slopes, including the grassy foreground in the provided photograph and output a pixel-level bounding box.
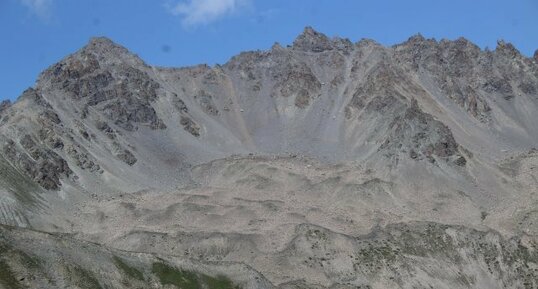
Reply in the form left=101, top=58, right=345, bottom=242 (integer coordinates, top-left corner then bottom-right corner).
left=0, top=157, right=538, bottom=289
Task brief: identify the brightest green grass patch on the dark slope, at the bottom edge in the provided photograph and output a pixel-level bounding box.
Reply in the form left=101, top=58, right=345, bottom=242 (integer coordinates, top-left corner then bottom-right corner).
left=152, top=263, right=239, bottom=289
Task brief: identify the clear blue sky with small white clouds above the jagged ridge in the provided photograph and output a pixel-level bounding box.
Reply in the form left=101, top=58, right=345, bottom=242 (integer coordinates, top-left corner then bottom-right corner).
left=0, top=0, right=538, bottom=100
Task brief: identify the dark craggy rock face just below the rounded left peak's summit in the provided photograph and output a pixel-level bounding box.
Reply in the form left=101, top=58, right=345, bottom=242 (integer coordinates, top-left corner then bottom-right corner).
left=43, top=39, right=166, bottom=131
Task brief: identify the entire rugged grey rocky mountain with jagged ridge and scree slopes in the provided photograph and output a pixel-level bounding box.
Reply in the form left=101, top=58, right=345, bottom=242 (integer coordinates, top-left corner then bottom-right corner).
left=0, top=27, right=538, bottom=288
